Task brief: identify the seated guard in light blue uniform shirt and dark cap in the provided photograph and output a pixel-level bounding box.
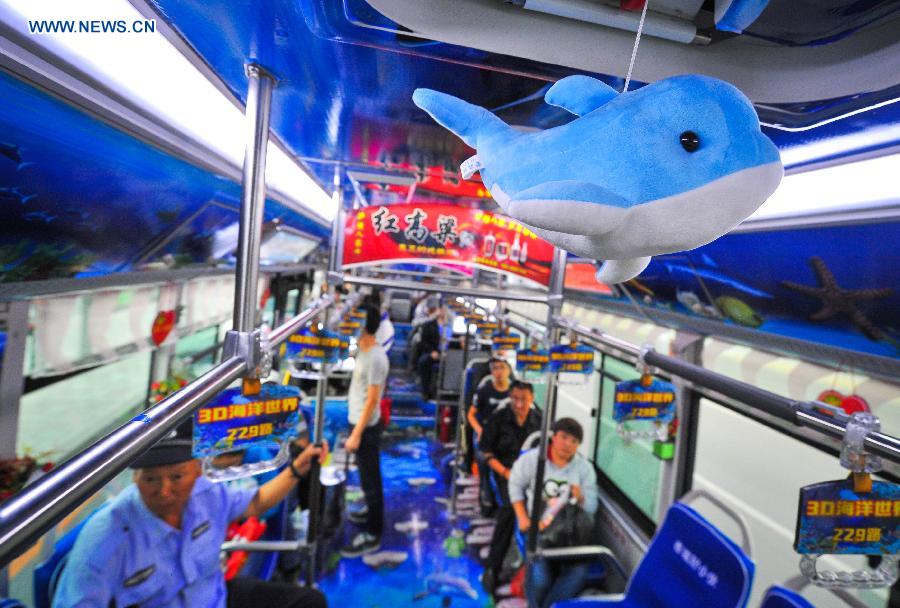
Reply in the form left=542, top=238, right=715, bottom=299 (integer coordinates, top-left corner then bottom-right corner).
left=53, top=427, right=328, bottom=608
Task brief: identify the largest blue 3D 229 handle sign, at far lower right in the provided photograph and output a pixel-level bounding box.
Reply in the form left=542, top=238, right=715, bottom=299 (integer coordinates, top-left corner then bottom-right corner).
left=794, top=479, right=900, bottom=555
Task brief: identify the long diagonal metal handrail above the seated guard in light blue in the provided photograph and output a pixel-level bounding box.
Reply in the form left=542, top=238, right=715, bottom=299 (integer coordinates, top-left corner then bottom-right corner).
left=0, top=296, right=332, bottom=568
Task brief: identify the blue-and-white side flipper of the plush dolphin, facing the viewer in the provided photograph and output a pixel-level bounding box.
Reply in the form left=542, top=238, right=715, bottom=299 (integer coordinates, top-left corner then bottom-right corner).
left=506, top=180, right=630, bottom=235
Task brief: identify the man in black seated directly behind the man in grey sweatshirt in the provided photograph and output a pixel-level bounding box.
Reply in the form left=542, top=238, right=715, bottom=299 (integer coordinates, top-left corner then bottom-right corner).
left=478, top=382, right=541, bottom=592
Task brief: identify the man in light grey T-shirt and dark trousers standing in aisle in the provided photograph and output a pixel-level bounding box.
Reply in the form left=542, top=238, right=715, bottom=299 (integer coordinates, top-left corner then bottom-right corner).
left=341, top=305, right=389, bottom=557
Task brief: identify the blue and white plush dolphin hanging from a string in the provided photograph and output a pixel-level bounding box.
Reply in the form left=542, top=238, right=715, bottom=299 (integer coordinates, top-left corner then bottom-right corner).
left=413, top=75, right=784, bottom=283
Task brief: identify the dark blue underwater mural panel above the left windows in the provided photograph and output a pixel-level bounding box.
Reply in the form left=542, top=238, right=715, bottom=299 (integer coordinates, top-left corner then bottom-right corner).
left=0, top=74, right=327, bottom=282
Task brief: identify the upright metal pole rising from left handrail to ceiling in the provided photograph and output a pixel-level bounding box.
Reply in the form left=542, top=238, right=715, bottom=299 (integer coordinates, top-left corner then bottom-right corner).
left=233, top=65, right=275, bottom=332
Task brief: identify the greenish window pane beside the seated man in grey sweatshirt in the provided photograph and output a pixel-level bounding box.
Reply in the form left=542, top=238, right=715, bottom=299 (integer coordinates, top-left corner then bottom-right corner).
left=595, top=356, right=664, bottom=522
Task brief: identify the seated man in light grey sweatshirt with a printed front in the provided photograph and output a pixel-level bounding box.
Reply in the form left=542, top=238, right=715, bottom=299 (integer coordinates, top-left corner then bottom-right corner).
left=509, top=418, right=598, bottom=608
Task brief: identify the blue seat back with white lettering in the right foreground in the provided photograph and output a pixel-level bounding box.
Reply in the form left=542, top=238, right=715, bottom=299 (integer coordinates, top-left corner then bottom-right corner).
left=554, top=503, right=754, bottom=608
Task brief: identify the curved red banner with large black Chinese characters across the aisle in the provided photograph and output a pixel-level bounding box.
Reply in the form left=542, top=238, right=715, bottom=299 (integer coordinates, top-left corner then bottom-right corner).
left=344, top=203, right=553, bottom=285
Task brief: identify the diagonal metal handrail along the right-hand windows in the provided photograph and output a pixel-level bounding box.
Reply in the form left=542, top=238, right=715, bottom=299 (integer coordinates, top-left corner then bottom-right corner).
left=555, top=317, right=900, bottom=464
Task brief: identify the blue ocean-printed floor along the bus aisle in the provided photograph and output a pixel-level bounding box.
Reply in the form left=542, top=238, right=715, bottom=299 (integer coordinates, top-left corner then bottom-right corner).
left=319, top=438, right=491, bottom=608
